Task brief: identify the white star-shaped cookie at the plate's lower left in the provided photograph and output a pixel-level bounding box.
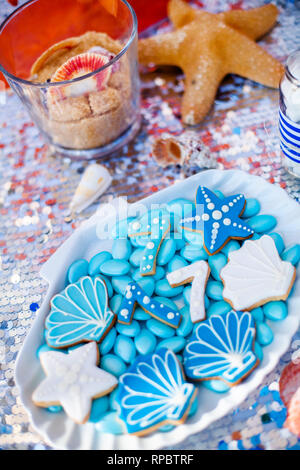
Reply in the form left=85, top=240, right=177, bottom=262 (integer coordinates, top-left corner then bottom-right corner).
left=32, top=341, right=118, bottom=424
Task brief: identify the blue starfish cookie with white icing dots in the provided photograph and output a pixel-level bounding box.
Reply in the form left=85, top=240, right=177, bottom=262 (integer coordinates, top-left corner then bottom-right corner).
left=181, top=186, right=254, bottom=254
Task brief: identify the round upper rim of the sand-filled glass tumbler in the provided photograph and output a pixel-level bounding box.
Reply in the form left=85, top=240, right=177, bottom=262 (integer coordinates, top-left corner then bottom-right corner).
left=0, top=0, right=138, bottom=88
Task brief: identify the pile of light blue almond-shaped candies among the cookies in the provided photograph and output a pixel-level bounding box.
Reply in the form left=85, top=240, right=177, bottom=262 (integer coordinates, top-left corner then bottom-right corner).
left=37, top=191, right=300, bottom=434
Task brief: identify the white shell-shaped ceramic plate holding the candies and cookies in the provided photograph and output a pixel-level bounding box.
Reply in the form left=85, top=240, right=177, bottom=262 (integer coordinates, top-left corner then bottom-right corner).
left=15, top=170, right=300, bottom=450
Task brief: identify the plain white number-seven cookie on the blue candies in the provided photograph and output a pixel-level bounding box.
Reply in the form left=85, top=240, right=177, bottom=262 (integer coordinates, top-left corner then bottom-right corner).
left=167, top=260, right=210, bottom=323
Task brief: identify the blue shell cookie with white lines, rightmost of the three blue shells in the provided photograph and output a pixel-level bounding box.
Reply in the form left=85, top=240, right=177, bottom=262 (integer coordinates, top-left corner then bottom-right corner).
left=184, top=310, right=258, bottom=386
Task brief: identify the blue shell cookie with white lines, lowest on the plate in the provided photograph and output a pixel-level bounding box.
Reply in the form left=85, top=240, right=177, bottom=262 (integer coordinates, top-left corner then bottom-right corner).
left=117, top=348, right=197, bottom=435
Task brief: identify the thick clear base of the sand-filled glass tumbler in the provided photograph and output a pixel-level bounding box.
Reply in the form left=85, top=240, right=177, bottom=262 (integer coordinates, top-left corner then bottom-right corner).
left=49, top=115, right=141, bottom=160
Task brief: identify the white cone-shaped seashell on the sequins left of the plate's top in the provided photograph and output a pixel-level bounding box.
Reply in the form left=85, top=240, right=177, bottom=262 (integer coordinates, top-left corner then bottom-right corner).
left=69, top=163, right=112, bottom=214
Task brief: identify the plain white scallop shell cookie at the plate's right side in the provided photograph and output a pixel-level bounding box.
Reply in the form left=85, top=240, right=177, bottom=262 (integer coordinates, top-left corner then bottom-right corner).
left=220, top=235, right=295, bottom=310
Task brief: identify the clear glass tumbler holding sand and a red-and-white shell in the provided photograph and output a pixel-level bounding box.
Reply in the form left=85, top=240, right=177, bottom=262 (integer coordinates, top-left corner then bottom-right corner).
left=0, top=0, right=140, bottom=159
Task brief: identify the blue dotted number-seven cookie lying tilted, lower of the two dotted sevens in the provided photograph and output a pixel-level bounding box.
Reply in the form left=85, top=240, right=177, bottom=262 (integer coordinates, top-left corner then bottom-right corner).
left=118, top=281, right=181, bottom=328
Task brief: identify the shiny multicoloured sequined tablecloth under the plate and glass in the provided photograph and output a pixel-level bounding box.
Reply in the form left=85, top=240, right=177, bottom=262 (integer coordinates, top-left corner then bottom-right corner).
left=0, top=0, right=300, bottom=449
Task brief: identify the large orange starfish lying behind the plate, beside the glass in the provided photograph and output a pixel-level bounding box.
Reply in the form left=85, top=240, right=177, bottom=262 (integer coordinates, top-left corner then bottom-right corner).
left=139, top=0, right=284, bottom=125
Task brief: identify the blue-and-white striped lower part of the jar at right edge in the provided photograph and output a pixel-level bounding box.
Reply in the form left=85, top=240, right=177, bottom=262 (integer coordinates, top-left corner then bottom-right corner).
left=279, top=109, right=300, bottom=166
